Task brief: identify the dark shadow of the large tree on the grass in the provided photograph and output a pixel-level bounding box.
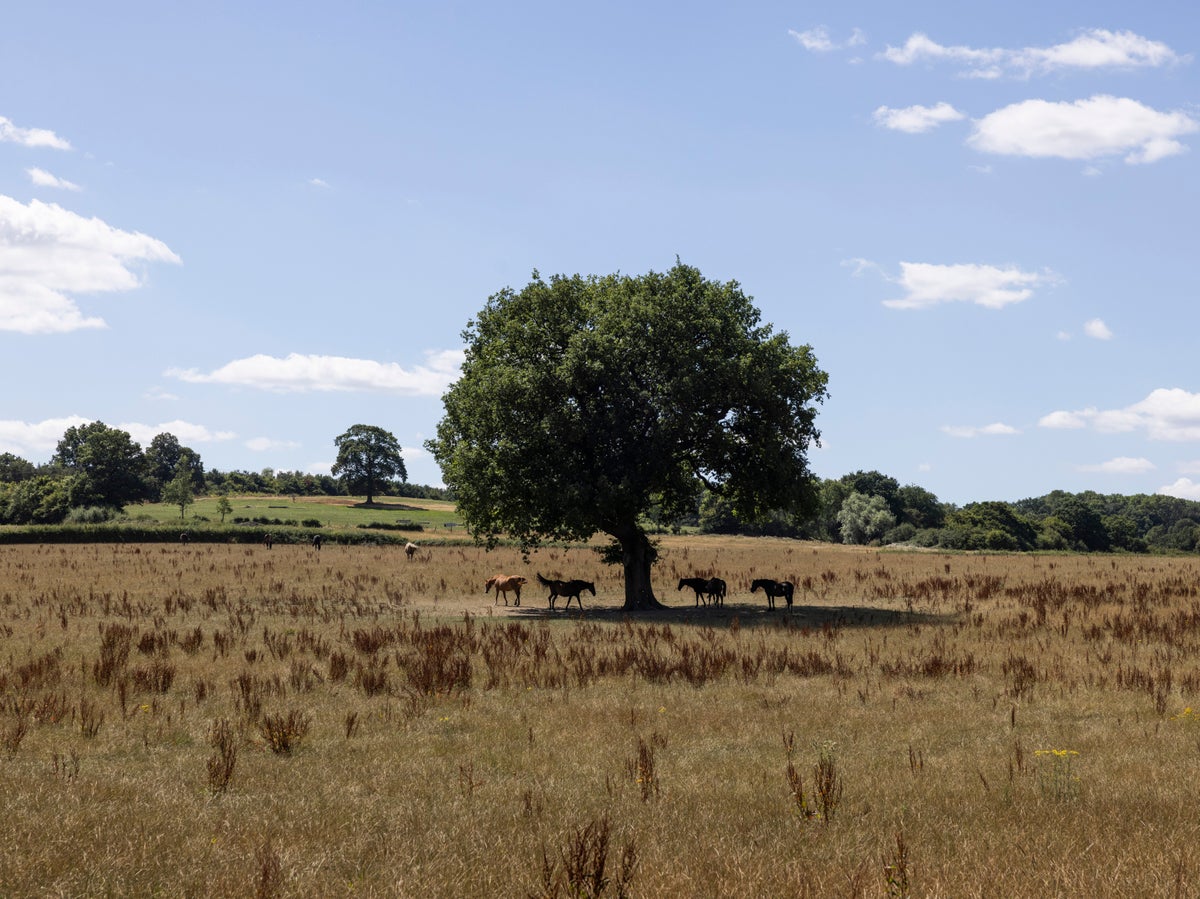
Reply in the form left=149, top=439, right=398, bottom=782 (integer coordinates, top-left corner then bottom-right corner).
left=508, top=600, right=960, bottom=630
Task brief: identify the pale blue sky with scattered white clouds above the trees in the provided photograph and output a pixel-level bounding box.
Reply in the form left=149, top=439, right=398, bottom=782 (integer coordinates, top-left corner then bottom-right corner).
left=0, top=0, right=1200, bottom=505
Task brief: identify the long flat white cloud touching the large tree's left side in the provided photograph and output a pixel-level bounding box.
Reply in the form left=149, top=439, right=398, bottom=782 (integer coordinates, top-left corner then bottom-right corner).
left=166, top=349, right=463, bottom=396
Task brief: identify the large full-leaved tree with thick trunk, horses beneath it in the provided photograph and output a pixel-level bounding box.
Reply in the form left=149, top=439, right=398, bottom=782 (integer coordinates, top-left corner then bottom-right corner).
left=427, top=263, right=827, bottom=609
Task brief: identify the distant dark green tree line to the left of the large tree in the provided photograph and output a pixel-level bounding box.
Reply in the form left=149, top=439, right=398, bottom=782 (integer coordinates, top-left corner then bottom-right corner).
left=0, top=421, right=446, bottom=525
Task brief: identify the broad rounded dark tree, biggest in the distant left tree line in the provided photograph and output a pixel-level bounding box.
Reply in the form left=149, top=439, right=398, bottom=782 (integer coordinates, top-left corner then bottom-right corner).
left=52, top=421, right=149, bottom=509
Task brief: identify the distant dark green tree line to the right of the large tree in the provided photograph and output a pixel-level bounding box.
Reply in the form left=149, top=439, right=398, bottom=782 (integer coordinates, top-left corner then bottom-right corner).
left=696, top=472, right=1200, bottom=552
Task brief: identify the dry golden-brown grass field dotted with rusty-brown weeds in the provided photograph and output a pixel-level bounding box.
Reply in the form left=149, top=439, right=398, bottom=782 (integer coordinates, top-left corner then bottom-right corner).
left=0, top=538, right=1200, bottom=897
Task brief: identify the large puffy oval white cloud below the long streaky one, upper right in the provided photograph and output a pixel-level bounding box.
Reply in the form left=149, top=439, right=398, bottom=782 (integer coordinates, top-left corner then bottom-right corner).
left=967, top=95, right=1200, bottom=164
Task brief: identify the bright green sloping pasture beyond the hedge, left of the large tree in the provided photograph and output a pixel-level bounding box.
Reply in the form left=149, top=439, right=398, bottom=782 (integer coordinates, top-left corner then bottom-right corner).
left=125, top=496, right=466, bottom=538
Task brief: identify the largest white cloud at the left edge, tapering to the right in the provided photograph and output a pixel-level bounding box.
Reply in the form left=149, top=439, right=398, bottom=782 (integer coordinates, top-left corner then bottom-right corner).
left=0, top=196, right=180, bottom=334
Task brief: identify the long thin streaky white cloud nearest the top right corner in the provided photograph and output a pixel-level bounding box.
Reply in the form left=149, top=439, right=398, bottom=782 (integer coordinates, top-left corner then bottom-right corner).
left=880, top=29, right=1187, bottom=78
